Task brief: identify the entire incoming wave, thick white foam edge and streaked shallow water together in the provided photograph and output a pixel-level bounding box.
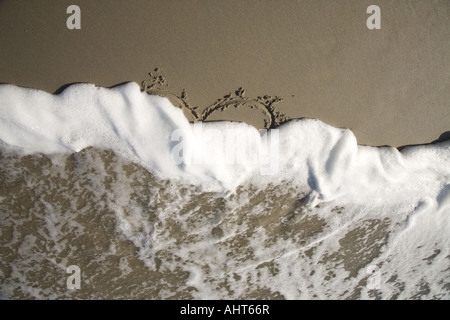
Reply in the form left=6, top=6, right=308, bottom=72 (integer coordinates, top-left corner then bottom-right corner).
left=0, top=83, right=450, bottom=299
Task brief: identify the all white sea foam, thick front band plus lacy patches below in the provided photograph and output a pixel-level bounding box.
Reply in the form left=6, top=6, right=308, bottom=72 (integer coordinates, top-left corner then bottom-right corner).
left=0, top=83, right=450, bottom=298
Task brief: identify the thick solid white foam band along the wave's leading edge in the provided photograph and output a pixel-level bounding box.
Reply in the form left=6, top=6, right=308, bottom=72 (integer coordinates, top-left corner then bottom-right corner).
left=0, top=83, right=450, bottom=200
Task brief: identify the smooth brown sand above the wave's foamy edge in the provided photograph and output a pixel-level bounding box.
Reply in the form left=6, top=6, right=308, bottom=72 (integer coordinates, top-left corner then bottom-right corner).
left=0, top=0, right=450, bottom=146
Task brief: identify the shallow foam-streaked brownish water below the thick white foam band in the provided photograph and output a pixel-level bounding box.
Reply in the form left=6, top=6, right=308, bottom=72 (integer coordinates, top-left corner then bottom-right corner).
left=0, top=147, right=450, bottom=299
